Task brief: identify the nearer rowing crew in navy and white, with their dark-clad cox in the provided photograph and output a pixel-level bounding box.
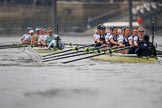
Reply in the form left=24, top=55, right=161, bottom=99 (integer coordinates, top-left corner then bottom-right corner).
left=93, top=24, right=156, bottom=57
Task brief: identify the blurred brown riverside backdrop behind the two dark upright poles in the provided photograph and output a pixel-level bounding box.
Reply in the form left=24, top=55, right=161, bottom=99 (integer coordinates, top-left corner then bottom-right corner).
left=0, top=0, right=162, bottom=35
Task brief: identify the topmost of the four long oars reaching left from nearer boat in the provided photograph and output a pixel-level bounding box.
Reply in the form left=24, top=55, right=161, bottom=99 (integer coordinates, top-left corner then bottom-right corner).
left=42, top=44, right=94, bottom=58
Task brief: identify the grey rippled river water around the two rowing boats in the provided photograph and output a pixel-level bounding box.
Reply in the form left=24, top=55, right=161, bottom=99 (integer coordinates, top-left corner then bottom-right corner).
left=0, top=36, right=162, bottom=108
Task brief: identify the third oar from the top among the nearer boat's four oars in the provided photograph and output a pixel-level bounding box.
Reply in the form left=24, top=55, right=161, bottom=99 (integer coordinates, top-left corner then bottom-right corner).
left=43, top=46, right=107, bottom=62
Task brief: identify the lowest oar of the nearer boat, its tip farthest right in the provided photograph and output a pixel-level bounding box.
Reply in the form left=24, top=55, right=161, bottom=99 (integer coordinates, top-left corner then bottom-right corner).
left=62, top=46, right=131, bottom=64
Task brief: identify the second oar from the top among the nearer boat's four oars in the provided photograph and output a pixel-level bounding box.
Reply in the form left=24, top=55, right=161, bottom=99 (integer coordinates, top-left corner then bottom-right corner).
left=43, top=46, right=102, bottom=60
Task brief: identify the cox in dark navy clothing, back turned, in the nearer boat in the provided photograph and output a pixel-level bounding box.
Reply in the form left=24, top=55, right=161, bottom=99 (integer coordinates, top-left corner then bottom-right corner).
left=135, top=35, right=157, bottom=58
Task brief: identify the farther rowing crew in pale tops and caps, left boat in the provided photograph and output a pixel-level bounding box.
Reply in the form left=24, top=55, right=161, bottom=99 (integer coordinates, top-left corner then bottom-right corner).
left=21, top=27, right=64, bottom=49
